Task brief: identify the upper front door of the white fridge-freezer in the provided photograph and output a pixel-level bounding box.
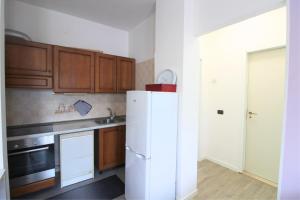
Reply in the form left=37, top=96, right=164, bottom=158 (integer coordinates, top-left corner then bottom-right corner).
left=126, top=91, right=151, bottom=158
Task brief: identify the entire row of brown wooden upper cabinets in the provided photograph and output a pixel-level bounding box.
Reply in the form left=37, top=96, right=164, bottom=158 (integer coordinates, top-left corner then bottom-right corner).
left=5, top=37, right=135, bottom=93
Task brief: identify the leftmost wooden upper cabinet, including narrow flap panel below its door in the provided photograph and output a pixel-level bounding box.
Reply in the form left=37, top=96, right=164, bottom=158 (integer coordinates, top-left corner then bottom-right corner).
left=5, top=36, right=53, bottom=89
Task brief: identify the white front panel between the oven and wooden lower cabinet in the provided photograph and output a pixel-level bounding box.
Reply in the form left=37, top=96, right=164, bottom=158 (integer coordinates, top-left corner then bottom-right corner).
left=60, top=131, right=94, bottom=187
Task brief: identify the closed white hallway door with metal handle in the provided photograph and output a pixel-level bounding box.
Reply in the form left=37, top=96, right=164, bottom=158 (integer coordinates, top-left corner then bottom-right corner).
left=245, top=48, right=285, bottom=184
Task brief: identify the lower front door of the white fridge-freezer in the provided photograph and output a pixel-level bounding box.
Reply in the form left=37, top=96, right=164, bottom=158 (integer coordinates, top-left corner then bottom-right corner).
left=125, top=148, right=150, bottom=200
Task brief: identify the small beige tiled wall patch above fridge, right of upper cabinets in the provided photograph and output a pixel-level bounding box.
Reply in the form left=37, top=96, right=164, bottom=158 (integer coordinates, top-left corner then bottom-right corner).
left=135, top=59, right=154, bottom=90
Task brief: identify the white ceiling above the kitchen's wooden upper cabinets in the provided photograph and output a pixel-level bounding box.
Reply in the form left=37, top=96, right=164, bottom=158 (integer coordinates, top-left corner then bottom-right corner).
left=19, top=0, right=155, bottom=30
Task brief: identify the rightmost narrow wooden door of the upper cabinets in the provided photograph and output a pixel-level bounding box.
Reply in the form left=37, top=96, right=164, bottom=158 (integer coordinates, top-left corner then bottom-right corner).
left=117, top=57, right=135, bottom=93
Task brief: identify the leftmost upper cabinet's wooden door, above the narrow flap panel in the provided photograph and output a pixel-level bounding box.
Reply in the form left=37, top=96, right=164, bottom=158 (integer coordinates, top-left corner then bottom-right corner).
left=5, top=40, right=52, bottom=76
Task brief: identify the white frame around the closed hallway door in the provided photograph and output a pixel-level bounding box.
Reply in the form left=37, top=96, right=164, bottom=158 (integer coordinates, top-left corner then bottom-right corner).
left=240, top=45, right=288, bottom=184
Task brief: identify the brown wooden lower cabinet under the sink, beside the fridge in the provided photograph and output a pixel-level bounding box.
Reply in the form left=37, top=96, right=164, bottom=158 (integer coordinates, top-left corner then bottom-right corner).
left=95, top=126, right=125, bottom=171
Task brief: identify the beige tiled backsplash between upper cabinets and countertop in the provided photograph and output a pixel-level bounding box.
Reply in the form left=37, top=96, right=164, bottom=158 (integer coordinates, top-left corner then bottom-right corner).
left=6, top=89, right=126, bottom=126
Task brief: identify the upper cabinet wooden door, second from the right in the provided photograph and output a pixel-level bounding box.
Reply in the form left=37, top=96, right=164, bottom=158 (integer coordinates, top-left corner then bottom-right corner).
left=95, top=54, right=117, bottom=93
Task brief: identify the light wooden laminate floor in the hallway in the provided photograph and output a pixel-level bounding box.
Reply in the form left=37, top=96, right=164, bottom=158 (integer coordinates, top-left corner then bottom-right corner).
left=193, top=160, right=277, bottom=200
